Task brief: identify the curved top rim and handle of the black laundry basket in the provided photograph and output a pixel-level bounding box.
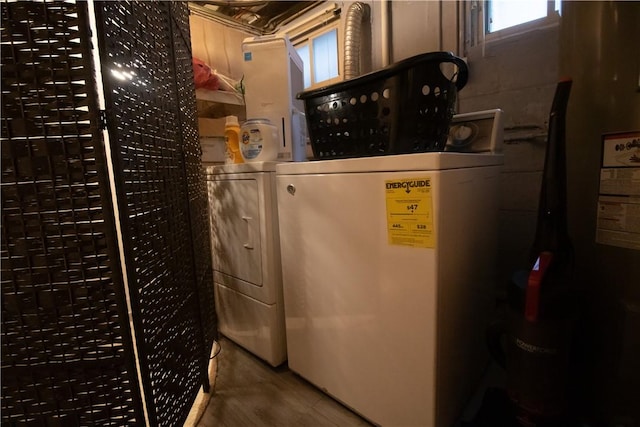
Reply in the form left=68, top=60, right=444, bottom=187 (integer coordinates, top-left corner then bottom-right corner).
left=296, top=52, right=469, bottom=99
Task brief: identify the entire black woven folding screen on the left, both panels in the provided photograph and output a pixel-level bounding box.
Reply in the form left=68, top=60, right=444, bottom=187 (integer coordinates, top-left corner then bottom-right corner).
left=0, top=1, right=216, bottom=426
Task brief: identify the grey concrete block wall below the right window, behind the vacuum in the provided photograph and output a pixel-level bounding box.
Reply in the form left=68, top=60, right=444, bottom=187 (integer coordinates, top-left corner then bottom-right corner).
left=458, top=27, right=558, bottom=293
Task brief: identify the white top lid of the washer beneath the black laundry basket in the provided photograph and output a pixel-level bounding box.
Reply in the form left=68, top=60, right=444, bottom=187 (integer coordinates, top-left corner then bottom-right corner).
left=276, top=152, right=504, bottom=175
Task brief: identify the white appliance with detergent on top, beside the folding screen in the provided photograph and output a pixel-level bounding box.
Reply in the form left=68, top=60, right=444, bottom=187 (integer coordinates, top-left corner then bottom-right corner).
left=206, top=162, right=287, bottom=366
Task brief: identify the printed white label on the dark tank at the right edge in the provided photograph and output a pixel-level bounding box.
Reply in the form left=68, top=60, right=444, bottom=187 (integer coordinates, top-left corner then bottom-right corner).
left=596, top=132, right=640, bottom=250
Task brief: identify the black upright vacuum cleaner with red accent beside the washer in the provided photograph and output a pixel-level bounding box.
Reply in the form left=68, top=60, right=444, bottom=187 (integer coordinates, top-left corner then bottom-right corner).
left=488, top=79, right=576, bottom=427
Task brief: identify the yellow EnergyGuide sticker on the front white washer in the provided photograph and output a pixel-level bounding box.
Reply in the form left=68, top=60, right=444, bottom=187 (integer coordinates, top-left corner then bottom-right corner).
left=385, top=177, right=435, bottom=248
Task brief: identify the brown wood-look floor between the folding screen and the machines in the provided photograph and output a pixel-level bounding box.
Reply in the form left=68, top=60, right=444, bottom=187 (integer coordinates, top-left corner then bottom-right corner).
left=197, top=337, right=372, bottom=427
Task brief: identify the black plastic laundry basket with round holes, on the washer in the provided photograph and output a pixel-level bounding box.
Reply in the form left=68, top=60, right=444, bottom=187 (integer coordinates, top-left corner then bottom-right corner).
left=297, top=52, right=468, bottom=160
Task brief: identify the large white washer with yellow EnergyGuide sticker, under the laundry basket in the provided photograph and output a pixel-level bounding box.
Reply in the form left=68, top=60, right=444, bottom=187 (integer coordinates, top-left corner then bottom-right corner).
left=276, top=152, right=503, bottom=427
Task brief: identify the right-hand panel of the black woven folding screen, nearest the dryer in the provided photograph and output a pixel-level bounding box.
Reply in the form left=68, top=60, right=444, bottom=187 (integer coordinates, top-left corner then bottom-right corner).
left=96, top=1, right=214, bottom=425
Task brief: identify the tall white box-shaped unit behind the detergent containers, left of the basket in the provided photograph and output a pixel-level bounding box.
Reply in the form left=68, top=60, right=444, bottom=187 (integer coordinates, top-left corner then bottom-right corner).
left=242, top=35, right=307, bottom=162
